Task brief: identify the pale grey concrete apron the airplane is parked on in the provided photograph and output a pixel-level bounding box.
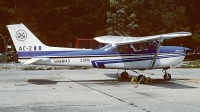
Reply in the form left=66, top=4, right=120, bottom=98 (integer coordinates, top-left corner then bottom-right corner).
left=0, top=69, right=200, bottom=112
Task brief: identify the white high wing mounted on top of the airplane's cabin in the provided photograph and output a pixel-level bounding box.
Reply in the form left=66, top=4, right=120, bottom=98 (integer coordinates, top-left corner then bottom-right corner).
left=94, top=32, right=192, bottom=45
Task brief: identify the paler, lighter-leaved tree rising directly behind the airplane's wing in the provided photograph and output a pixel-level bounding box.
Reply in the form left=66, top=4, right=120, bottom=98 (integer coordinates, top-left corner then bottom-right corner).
left=107, top=0, right=138, bottom=35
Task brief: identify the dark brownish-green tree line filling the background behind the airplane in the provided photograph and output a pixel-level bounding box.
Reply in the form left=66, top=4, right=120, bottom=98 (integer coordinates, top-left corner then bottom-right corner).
left=0, top=0, right=200, bottom=52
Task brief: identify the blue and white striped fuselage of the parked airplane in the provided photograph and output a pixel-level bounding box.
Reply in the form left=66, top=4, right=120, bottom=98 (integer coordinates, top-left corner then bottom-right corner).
left=19, top=42, right=185, bottom=69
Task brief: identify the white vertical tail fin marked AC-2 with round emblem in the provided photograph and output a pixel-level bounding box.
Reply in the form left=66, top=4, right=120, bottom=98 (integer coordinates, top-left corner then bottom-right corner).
left=7, top=24, right=83, bottom=59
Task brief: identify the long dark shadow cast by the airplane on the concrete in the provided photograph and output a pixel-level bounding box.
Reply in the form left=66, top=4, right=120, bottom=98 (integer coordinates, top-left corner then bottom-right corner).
left=27, top=78, right=197, bottom=89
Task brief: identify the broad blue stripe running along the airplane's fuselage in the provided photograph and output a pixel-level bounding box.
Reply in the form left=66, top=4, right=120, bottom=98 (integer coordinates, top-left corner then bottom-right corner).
left=18, top=46, right=183, bottom=59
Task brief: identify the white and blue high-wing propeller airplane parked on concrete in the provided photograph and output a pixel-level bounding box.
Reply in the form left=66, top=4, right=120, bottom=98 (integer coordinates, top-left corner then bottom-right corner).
left=7, top=24, right=192, bottom=83
